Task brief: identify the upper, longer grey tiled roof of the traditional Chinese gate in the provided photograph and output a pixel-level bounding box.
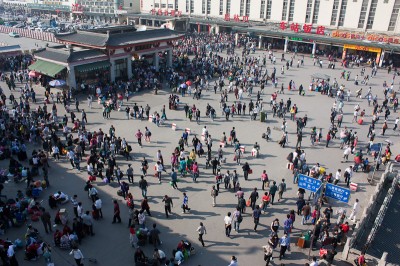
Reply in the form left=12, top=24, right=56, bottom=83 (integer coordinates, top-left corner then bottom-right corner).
left=56, top=29, right=184, bottom=48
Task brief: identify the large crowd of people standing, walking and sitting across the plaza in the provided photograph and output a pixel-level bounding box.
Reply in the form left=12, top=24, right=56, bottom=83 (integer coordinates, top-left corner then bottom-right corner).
left=0, top=28, right=399, bottom=266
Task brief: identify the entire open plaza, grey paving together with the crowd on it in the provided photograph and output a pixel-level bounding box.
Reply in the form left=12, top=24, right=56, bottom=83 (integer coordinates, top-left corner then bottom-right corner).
left=0, top=33, right=399, bottom=266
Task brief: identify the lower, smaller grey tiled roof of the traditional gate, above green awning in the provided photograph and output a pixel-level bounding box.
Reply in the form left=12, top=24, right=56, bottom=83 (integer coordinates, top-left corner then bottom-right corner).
left=35, top=47, right=105, bottom=63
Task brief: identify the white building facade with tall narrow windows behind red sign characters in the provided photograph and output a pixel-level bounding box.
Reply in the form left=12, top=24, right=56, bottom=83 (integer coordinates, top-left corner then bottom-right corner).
left=137, top=0, right=400, bottom=34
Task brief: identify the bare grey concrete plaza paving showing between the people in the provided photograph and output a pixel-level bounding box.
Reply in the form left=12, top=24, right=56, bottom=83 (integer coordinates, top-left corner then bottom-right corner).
left=1, top=35, right=399, bottom=266
